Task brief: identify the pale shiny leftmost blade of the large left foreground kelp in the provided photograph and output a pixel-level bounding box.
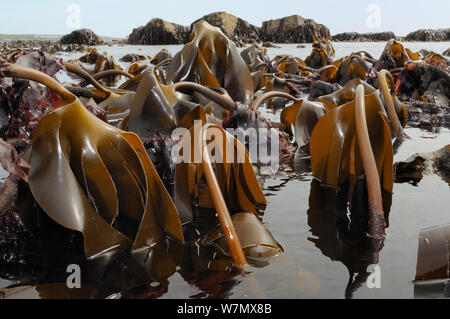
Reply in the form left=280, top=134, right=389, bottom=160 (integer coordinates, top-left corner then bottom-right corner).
left=29, top=102, right=131, bottom=257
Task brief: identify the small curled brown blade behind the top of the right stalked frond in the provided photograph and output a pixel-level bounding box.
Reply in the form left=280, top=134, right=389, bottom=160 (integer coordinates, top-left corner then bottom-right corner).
left=317, top=78, right=376, bottom=110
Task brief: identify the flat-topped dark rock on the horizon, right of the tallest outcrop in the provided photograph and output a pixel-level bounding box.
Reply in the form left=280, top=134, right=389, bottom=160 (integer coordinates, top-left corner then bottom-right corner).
left=260, top=15, right=330, bottom=43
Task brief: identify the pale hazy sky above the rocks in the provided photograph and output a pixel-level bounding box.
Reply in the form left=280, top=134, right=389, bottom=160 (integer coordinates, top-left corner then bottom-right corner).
left=0, top=0, right=450, bottom=37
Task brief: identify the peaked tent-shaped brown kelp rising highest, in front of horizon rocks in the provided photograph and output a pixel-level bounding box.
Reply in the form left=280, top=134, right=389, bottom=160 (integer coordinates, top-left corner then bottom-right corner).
left=166, top=21, right=254, bottom=104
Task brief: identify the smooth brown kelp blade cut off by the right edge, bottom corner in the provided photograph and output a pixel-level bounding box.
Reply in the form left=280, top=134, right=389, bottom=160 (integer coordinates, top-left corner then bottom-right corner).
left=416, top=225, right=450, bottom=280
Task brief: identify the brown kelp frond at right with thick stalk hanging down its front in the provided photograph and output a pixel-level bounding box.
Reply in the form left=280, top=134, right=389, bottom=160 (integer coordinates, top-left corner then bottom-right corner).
left=310, top=85, right=393, bottom=238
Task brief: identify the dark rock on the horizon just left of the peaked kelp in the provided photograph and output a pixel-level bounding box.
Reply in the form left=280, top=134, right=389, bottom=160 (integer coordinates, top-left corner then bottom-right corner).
left=128, top=18, right=189, bottom=45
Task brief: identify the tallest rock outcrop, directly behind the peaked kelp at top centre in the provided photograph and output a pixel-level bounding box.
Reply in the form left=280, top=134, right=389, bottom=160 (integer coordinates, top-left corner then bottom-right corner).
left=191, top=12, right=259, bottom=43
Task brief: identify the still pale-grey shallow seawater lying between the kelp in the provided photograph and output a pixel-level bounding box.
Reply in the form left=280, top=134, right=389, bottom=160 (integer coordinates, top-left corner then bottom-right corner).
left=0, top=42, right=450, bottom=298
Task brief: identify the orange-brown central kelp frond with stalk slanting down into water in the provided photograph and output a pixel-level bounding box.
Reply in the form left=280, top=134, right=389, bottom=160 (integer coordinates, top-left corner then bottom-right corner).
left=175, top=124, right=266, bottom=262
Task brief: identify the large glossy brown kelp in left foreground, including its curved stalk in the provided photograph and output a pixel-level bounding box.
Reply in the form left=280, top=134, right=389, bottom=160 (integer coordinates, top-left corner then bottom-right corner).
left=3, top=65, right=183, bottom=257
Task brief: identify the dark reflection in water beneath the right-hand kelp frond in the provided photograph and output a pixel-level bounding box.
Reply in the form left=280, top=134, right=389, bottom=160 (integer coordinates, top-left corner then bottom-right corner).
left=308, top=180, right=391, bottom=298
